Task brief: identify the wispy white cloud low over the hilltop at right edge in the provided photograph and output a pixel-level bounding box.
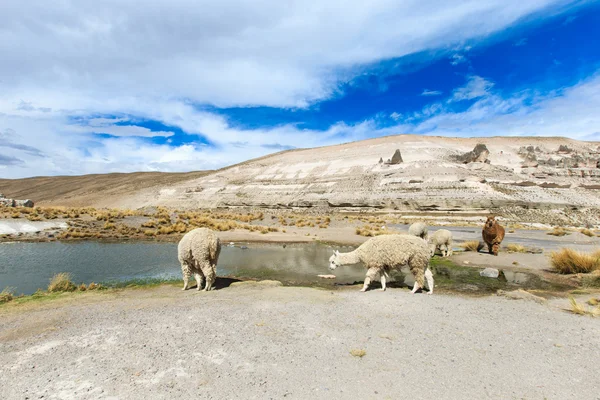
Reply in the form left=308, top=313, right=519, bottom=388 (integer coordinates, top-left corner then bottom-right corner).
left=406, top=72, right=600, bottom=140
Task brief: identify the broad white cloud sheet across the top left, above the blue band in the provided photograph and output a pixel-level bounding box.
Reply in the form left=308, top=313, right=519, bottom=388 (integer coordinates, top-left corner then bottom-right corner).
left=0, top=0, right=576, bottom=109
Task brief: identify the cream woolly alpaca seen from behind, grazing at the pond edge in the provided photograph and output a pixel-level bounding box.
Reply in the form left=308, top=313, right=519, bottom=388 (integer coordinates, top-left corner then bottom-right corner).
left=177, top=228, right=221, bottom=290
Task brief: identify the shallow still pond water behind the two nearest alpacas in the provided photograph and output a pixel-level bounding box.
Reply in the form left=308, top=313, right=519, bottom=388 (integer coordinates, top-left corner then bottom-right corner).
left=0, top=242, right=560, bottom=294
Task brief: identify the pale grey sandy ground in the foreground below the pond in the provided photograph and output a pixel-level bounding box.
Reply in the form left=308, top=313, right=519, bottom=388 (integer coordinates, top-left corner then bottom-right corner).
left=0, top=281, right=600, bottom=399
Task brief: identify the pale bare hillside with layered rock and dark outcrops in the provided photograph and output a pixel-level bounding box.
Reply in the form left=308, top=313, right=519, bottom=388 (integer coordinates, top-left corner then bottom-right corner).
left=0, top=135, right=600, bottom=211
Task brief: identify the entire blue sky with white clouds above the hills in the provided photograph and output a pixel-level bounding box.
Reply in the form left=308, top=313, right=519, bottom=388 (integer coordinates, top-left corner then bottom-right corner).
left=0, top=0, right=600, bottom=178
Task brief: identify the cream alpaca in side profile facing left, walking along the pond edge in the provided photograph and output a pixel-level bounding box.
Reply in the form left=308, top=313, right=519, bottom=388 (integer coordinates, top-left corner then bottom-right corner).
left=329, top=235, right=434, bottom=294
